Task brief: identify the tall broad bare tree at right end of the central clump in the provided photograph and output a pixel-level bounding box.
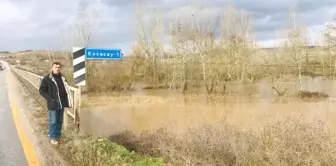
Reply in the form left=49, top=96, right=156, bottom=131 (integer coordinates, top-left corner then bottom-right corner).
left=220, top=5, right=252, bottom=94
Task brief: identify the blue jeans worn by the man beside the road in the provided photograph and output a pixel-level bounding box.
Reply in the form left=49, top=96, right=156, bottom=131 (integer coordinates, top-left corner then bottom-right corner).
left=49, top=108, right=64, bottom=140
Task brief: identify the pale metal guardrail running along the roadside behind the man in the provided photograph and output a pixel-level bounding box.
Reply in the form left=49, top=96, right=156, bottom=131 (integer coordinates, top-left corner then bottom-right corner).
left=10, top=66, right=81, bottom=129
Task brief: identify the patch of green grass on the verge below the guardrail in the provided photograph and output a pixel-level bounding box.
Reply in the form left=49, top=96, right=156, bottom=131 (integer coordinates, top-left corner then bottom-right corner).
left=59, top=135, right=165, bottom=166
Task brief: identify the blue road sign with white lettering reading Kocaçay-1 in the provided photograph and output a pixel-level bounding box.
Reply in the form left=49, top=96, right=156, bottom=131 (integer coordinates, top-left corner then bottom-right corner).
left=85, top=48, right=122, bottom=60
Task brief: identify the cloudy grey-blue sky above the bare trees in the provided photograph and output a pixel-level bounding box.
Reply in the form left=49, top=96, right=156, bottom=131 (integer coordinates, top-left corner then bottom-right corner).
left=0, top=0, right=336, bottom=54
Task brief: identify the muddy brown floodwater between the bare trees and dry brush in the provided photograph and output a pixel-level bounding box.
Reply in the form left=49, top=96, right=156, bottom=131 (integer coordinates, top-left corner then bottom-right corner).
left=80, top=77, right=336, bottom=137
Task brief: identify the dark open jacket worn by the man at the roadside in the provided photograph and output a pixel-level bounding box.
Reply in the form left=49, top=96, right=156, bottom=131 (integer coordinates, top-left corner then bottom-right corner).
left=39, top=73, right=72, bottom=110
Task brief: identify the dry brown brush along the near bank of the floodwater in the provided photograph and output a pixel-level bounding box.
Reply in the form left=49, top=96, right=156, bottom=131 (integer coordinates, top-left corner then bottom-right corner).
left=110, top=116, right=336, bottom=166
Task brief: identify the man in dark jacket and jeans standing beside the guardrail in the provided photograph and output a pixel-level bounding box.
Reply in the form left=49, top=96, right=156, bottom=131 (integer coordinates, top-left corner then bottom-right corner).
left=39, top=62, right=72, bottom=145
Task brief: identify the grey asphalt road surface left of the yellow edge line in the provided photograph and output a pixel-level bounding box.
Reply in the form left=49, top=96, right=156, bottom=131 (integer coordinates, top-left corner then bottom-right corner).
left=0, top=66, right=28, bottom=166
